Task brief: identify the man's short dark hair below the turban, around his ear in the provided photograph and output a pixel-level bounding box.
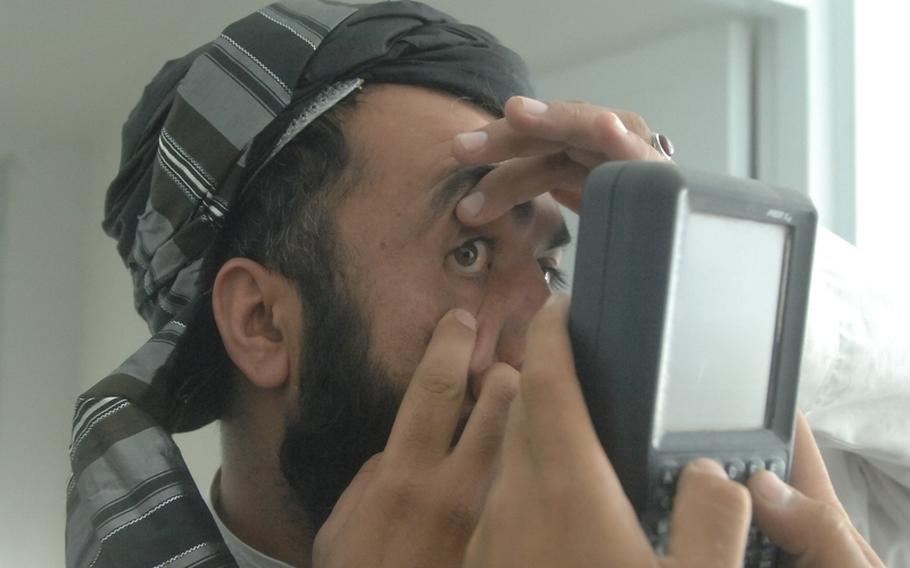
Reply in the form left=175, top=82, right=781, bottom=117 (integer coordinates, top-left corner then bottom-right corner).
left=166, top=93, right=357, bottom=432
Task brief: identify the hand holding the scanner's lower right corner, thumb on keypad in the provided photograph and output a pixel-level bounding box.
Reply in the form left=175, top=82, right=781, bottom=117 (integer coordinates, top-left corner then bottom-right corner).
left=749, top=413, right=884, bottom=568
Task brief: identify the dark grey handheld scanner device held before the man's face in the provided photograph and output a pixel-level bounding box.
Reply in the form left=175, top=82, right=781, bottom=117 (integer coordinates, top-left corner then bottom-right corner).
left=569, top=162, right=816, bottom=566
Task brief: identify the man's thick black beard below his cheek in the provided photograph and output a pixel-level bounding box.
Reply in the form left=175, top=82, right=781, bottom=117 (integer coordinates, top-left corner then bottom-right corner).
left=279, top=278, right=404, bottom=537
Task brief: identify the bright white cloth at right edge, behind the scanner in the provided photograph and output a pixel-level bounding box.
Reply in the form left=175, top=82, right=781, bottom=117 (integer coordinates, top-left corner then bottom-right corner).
left=799, top=229, right=910, bottom=568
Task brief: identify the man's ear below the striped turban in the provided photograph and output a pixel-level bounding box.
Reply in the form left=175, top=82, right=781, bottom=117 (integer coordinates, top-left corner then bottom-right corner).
left=212, top=258, right=303, bottom=389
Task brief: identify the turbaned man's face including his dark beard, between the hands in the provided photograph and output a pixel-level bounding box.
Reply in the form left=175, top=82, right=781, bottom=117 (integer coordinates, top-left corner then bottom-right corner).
left=280, top=86, right=568, bottom=533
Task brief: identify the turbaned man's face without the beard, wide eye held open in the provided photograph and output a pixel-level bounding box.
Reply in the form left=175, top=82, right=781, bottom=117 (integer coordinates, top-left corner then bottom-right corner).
left=336, top=85, right=568, bottom=396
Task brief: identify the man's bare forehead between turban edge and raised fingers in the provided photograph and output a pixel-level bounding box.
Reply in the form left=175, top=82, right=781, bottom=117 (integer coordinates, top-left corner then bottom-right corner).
left=339, top=85, right=561, bottom=251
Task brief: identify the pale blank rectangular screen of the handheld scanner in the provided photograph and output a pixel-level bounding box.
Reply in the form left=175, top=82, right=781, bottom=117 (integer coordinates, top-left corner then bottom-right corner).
left=654, top=197, right=788, bottom=441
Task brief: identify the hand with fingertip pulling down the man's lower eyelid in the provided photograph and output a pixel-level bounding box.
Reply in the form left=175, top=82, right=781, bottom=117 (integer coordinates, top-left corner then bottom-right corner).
left=313, top=310, right=517, bottom=568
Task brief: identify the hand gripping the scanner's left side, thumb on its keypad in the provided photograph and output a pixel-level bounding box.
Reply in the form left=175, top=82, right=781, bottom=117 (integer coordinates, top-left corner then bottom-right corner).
left=465, top=296, right=751, bottom=568
